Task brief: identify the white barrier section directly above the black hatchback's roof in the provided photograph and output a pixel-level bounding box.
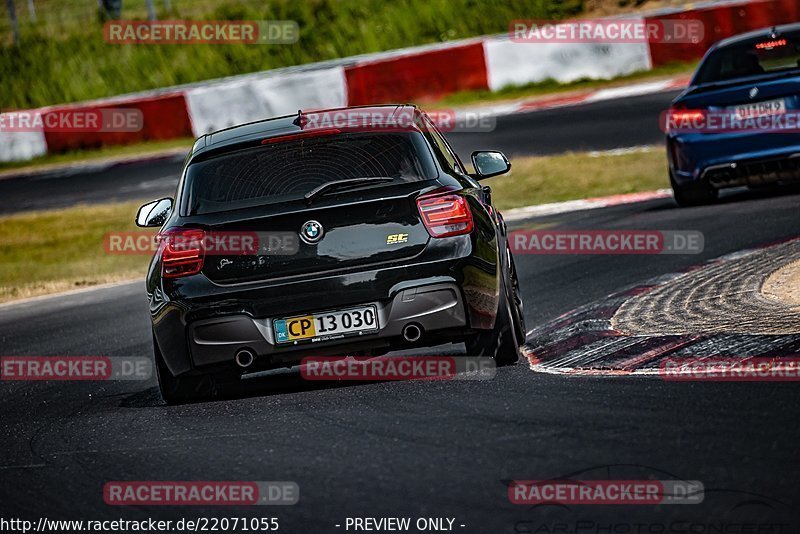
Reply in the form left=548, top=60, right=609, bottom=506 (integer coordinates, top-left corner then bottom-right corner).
left=186, top=67, right=347, bottom=136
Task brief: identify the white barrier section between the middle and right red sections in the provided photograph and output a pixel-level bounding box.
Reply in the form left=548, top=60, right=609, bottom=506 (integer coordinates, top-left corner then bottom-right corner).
left=483, top=19, right=652, bottom=91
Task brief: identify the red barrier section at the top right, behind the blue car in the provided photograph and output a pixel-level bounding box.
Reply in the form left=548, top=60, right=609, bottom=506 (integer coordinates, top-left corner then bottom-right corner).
left=645, top=0, right=800, bottom=67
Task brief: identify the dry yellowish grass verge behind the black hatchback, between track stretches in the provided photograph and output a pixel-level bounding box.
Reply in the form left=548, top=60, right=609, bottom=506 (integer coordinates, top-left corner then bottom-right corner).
left=0, top=148, right=666, bottom=302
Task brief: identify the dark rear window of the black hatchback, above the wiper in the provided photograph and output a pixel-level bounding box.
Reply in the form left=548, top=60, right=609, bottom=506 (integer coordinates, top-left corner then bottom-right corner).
left=184, top=132, right=438, bottom=215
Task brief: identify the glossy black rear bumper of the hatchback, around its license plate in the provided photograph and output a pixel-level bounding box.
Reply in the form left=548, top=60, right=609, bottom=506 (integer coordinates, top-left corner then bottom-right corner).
left=148, top=235, right=500, bottom=375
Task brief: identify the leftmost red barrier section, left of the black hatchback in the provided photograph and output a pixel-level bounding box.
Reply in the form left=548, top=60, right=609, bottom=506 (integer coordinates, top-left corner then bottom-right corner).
left=44, top=93, right=192, bottom=153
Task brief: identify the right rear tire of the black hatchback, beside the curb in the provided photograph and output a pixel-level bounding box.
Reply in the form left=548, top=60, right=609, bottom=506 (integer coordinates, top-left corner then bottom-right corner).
left=466, top=256, right=525, bottom=367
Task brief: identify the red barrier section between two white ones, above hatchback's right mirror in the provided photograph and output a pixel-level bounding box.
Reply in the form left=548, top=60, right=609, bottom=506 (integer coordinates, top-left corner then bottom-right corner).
left=345, top=42, right=489, bottom=106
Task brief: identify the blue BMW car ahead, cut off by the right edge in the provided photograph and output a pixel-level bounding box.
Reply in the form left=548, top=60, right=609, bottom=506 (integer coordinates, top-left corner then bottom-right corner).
left=662, top=24, right=800, bottom=206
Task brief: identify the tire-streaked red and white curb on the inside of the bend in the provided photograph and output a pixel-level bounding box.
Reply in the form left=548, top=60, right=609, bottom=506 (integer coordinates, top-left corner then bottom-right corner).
left=523, top=239, right=800, bottom=376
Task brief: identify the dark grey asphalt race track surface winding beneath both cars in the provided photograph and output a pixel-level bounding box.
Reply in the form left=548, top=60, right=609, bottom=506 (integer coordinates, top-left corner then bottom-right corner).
left=0, top=87, right=800, bottom=534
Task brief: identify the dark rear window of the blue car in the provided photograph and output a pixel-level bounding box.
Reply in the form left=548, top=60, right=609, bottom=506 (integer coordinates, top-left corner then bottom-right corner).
left=695, top=32, right=800, bottom=85
